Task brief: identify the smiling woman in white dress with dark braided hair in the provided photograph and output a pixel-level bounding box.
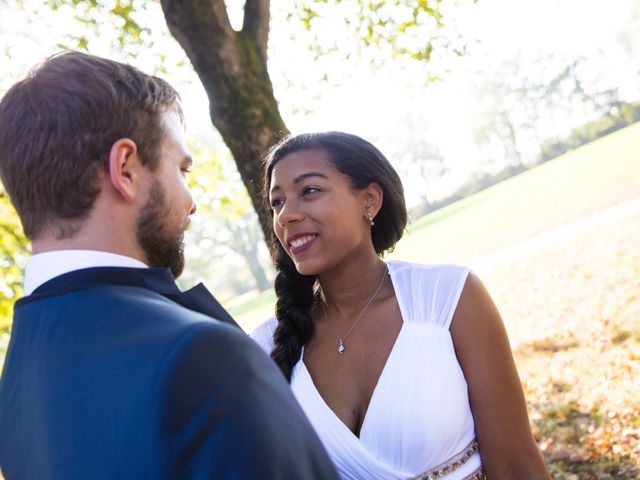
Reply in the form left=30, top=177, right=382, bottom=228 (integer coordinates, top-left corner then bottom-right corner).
left=252, top=132, right=549, bottom=480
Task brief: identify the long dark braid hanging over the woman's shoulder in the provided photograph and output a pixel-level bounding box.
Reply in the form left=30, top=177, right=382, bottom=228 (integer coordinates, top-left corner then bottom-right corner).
left=271, top=244, right=316, bottom=382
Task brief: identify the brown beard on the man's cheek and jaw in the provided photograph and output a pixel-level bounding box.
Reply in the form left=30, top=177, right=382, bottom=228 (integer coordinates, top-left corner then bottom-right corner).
left=136, top=181, right=184, bottom=278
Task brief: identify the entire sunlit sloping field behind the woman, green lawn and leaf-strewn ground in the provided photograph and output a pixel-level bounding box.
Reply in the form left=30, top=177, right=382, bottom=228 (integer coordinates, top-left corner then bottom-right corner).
left=234, top=124, right=640, bottom=480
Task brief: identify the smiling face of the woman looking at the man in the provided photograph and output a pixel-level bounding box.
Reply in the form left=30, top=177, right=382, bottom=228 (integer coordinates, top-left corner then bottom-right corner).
left=269, top=150, right=375, bottom=275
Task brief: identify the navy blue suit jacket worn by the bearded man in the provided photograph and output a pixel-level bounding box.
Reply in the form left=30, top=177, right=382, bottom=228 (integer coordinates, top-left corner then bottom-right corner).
left=0, top=268, right=337, bottom=480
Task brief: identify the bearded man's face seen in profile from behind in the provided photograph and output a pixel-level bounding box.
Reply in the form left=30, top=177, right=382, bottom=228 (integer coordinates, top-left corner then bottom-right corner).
left=136, top=112, right=196, bottom=278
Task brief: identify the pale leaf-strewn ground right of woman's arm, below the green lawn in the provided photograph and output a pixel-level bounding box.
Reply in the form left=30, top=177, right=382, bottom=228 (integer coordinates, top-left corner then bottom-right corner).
left=500, top=208, right=640, bottom=480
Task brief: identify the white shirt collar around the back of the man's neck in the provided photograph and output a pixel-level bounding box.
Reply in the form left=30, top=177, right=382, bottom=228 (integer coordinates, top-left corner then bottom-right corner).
left=23, top=250, right=148, bottom=296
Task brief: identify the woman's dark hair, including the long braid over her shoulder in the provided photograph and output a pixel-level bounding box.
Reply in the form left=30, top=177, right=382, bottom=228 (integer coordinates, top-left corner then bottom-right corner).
left=264, top=132, right=407, bottom=381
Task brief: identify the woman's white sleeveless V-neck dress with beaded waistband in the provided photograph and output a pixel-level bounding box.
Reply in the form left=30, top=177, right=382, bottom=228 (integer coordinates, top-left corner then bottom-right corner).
left=251, top=261, right=484, bottom=480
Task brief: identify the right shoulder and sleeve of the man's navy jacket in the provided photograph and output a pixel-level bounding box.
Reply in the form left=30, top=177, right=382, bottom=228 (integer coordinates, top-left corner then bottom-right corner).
left=152, top=312, right=337, bottom=479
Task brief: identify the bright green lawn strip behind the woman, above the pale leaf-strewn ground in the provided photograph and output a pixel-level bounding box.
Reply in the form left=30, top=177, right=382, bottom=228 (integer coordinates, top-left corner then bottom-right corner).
left=230, top=123, right=640, bottom=331
